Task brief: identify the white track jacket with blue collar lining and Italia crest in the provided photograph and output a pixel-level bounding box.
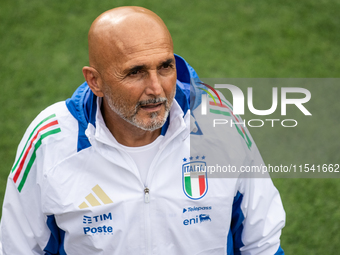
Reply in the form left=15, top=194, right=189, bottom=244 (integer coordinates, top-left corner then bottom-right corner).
left=0, top=55, right=285, bottom=255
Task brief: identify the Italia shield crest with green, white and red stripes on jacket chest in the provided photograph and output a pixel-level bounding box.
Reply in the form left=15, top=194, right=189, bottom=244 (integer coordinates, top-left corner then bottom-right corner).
left=182, top=161, right=208, bottom=200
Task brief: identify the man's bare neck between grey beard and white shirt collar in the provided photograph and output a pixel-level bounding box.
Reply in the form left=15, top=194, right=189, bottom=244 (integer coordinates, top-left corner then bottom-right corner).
left=101, top=100, right=161, bottom=147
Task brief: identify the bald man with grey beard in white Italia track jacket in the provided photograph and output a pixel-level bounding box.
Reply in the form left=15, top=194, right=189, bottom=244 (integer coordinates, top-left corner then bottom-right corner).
left=1, top=7, right=285, bottom=255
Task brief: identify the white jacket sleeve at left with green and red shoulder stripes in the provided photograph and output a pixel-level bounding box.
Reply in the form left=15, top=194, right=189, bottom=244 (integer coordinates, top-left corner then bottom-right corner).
left=0, top=112, right=60, bottom=255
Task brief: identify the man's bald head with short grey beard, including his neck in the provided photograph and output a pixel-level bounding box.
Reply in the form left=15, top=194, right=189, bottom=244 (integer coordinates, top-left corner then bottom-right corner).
left=83, top=7, right=177, bottom=143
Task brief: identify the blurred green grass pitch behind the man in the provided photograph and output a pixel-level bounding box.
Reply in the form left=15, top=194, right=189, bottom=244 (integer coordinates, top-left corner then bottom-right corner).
left=0, top=0, right=340, bottom=255
